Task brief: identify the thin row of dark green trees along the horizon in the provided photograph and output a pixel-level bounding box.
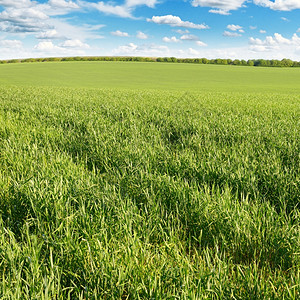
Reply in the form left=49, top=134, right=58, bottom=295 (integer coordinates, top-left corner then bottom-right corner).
left=0, top=56, right=300, bottom=67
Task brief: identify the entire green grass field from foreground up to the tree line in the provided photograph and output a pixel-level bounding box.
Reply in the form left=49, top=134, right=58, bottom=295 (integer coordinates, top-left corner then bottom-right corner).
left=0, top=62, right=300, bottom=299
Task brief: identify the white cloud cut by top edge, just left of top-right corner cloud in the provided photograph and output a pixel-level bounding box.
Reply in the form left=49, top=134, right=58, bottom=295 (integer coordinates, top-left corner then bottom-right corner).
left=192, top=0, right=245, bottom=15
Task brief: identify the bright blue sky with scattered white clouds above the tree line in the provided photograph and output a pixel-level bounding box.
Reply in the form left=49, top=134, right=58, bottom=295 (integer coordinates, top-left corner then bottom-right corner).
left=0, top=0, right=300, bottom=61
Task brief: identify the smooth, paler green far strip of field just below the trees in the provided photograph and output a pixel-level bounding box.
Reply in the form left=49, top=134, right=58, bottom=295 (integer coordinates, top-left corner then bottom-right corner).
left=0, top=62, right=300, bottom=94
